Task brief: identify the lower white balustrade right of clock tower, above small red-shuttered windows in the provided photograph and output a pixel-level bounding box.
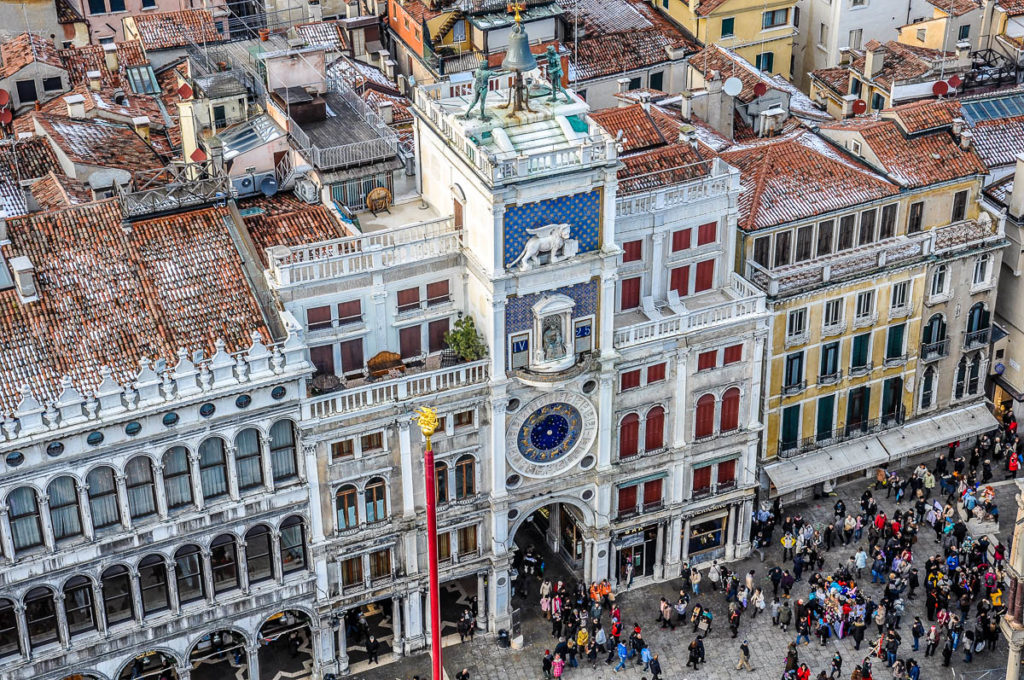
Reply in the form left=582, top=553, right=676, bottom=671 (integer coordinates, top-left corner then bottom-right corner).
left=613, top=273, right=765, bottom=348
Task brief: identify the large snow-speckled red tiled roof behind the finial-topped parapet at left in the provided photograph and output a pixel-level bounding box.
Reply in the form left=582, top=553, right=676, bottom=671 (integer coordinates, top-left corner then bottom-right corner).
left=0, top=199, right=270, bottom=412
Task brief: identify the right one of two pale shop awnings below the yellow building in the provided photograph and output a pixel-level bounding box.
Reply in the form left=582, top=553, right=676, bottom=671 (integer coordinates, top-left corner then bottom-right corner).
left=879, top=401, right=999, bottom=461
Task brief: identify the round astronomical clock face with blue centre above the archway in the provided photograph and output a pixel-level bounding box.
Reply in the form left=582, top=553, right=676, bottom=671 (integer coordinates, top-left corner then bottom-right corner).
left=507, top=393, right=597, bottom=477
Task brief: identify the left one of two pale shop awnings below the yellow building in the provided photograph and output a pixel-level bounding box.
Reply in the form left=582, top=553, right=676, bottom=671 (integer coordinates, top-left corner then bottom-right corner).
left=764, top=436, right=889, bottom=496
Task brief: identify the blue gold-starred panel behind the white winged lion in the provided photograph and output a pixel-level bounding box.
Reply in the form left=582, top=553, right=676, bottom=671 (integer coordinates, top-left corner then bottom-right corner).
left=505, top=189, right=601, bottom=266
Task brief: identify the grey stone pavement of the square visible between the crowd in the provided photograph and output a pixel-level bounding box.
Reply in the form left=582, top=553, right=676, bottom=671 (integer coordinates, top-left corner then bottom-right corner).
left=354, top=466, right=1016, bottom=680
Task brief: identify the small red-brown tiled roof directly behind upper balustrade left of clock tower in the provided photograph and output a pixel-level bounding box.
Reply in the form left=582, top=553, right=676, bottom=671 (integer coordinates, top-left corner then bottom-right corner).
left=239, top=194, right=346, bottom=265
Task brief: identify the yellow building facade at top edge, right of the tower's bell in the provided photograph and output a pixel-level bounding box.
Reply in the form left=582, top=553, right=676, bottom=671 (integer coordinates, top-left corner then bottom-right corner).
left=654, top=0, right=799, bottom=79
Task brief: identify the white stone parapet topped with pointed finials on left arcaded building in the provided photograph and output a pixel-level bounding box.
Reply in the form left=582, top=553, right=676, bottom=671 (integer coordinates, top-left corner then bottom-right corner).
left=0, top=319, right=312, bottom=441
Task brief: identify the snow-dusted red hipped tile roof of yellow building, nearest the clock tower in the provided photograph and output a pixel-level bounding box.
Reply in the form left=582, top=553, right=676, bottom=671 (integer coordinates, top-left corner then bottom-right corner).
left=720, top=130, right=899, bottom=231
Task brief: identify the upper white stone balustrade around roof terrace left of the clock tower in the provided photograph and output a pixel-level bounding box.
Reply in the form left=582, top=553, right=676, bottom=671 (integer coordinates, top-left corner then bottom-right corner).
left=267, top=217, right=462, bottom=287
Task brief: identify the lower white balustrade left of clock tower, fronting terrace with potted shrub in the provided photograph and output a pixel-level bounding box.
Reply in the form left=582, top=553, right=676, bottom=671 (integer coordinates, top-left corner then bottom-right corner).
left=302, top=359, right=490, bottom=420
